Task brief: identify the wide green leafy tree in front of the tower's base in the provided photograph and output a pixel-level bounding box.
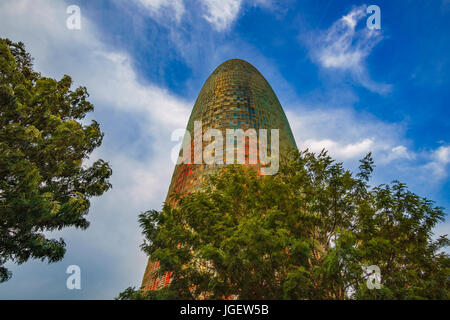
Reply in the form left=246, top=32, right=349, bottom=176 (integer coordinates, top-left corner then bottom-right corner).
left=119, top=151, right=450, bottom=299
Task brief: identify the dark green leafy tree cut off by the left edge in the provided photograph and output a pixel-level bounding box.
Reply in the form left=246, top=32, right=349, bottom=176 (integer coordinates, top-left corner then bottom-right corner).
left=0, top=38, right=112, bottom=282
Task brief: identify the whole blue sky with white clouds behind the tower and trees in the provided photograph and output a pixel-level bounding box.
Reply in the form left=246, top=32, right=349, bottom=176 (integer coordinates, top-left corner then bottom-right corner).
left=0, top=0, right=450, bottom=299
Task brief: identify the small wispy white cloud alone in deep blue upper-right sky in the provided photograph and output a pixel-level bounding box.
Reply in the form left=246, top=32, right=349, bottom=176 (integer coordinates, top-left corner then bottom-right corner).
left=306, top=6, right=391, bottom=94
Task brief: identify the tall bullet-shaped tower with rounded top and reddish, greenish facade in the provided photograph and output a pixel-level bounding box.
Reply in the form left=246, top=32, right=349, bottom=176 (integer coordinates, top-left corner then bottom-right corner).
left=141, top=59, right=297, bottom=291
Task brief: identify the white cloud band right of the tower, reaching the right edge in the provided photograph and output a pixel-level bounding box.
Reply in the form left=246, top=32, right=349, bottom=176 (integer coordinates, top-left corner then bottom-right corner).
left=286, top=106, right=450, bottom=186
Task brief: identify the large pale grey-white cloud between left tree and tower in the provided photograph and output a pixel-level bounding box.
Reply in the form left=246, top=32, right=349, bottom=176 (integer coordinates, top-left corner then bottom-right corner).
left=0, top=0, right=193, bottom=298
